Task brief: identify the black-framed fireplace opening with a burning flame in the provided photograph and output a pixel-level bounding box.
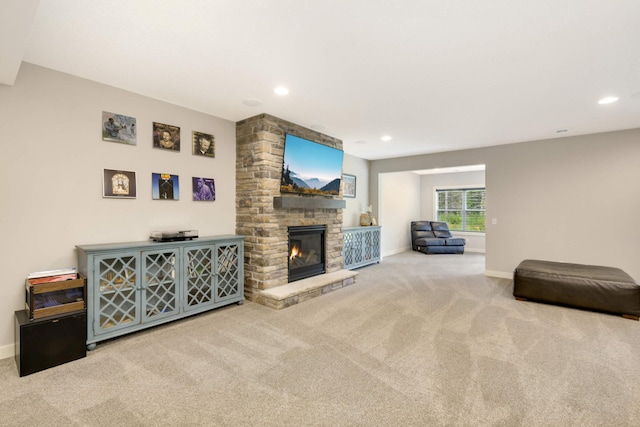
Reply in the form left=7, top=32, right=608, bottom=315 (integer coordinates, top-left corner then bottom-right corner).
left=289, top=225, right=327, bottom=282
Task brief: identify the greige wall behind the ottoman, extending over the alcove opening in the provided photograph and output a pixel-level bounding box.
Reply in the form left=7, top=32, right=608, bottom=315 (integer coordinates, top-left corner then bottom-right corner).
left=370, top=129, right=640, bottom=281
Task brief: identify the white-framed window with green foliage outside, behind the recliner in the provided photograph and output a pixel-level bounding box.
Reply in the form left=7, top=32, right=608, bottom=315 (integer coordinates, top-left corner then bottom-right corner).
left=436, top=188, right=487, bottom=233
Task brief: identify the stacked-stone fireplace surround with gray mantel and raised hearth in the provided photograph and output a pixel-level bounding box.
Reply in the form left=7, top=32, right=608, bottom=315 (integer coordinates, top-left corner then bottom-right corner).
left=236, top=114, right=357, bottom=308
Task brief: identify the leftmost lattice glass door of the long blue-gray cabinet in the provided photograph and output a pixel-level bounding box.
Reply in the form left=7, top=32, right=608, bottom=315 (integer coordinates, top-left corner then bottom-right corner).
left=93, top=253, right=140, bottom=334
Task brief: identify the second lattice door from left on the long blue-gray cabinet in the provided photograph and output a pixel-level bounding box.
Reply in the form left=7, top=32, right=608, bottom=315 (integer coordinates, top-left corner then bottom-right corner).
left=142, top=249, right=179, bottom=322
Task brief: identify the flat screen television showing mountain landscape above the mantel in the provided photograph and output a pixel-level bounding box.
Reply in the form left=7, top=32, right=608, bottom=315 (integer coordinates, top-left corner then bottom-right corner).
left=280, top=134, right=344, bottom=196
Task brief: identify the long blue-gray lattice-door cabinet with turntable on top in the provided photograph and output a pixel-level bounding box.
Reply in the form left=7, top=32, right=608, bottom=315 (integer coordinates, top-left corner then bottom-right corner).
left=76, top=235, right=244, bottom=350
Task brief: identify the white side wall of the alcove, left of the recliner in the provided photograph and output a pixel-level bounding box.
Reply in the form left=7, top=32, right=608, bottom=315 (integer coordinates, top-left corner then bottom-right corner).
left=377, top=172, right=421, bottom=256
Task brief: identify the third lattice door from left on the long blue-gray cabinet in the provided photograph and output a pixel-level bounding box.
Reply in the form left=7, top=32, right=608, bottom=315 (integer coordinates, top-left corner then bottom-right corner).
left=184, top=246, right=214, bottom=310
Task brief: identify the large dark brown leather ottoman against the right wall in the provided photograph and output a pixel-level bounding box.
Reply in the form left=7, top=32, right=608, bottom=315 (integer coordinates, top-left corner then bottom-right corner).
left=513, top=259, right=640, bottom=320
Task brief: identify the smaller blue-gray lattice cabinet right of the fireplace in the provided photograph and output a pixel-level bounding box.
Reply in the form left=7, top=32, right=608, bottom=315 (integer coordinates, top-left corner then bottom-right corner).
left=342, top=225, right=382, bottom=270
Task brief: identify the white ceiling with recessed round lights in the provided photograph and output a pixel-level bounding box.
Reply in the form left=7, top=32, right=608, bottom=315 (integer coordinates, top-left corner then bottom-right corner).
left=5, top=0, right=640, bottom=159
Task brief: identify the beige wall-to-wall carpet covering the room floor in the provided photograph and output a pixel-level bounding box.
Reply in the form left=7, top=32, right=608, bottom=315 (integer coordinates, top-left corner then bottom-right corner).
left=0, top=252, right=640, bottom=426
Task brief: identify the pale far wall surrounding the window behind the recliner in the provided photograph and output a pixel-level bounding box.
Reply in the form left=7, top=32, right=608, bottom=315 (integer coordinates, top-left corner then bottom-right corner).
left=419, top=171, right=485, bottom=252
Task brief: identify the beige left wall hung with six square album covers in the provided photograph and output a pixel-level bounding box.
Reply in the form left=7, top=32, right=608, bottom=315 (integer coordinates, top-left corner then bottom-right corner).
left=0, top=63, right=236, bottom=358
